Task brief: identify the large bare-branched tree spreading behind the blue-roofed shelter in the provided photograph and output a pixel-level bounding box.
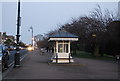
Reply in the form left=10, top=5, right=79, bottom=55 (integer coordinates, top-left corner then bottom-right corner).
left=35, top=5, right=114, bottom=56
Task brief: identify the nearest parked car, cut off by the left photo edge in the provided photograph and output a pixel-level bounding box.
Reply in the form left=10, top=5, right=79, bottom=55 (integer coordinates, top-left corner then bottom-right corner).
left=0, top=44, right=10, bottom=71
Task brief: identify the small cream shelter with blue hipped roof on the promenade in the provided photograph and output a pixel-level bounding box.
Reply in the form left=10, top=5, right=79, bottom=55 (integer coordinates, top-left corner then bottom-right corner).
left=48, top=30, right=78, bottom=63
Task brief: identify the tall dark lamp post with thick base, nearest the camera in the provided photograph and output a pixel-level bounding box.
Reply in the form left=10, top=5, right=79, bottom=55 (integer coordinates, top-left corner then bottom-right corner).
left=14, top=0, right=21, bottom=67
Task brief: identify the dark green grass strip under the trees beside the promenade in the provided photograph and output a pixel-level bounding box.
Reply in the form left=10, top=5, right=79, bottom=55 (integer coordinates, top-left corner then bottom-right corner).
left=72, top=51, right=116, bottom=61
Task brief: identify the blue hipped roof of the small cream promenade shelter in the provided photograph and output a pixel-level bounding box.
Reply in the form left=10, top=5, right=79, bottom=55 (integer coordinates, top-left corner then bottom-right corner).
left=49, top=30, right=78, bottom=38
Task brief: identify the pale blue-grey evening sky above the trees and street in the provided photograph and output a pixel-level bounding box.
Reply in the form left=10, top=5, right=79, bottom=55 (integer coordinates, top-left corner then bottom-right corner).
left=0, top=2, right=118, bottom=44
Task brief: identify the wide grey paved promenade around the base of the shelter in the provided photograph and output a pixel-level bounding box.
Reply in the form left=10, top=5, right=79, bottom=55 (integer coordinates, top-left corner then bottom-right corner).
left=4, top=50, right=118, bottom=79
